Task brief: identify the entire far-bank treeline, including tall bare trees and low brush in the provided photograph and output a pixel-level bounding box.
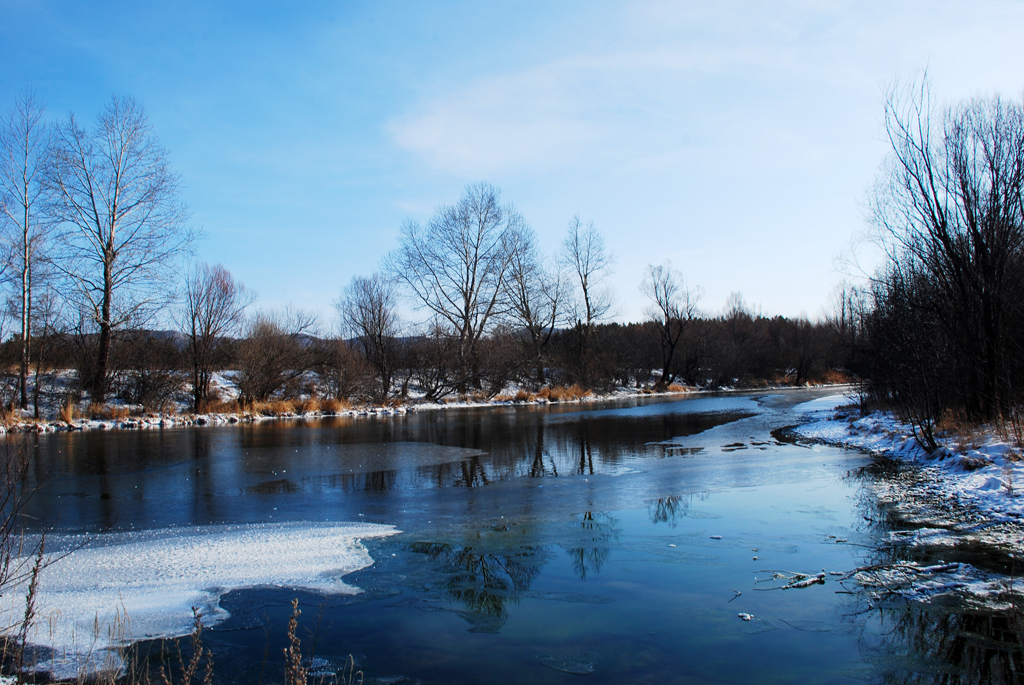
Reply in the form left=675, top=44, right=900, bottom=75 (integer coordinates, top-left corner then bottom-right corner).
left=0, top=88, right=855, bottom=414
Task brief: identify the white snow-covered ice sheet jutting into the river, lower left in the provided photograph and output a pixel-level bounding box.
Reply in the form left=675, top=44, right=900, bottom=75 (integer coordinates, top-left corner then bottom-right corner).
left=0, top=523, right=398, bottom=678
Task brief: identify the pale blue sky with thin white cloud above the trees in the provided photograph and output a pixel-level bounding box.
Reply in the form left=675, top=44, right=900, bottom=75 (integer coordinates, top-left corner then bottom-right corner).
left=0, top=0, right=1024, bottom=323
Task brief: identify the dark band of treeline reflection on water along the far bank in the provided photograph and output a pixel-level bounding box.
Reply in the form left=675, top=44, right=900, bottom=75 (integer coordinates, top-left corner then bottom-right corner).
left=22, top=397, right=756, bottom=531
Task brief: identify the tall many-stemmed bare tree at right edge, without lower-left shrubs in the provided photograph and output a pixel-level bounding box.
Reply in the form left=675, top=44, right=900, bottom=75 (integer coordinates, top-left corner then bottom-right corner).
left=871, top=77, right=1024, bottom=419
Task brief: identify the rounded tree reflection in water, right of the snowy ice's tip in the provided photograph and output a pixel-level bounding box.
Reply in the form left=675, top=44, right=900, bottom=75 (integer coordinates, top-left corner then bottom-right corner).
left=412, top=543, right=544, bottom=619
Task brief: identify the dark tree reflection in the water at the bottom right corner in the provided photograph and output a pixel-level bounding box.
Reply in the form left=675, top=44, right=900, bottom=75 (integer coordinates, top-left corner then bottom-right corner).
left=866, top=604, right=1024, bottom=685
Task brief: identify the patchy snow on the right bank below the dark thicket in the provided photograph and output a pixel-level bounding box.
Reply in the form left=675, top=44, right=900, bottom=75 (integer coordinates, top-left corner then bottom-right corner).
left=794, top=395, right=1024, bottom=608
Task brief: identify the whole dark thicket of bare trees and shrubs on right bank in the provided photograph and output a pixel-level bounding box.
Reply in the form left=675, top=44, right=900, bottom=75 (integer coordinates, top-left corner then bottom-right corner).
left=844, top=79, right=1024, bottom=448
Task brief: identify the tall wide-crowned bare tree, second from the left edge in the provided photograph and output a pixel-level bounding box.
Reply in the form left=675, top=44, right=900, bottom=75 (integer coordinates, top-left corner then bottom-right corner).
left=46, top=96, right=194, bottom=401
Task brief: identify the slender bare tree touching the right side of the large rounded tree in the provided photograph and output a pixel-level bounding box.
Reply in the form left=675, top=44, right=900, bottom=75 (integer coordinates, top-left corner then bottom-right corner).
left=507, top=226, right=562, bottom=385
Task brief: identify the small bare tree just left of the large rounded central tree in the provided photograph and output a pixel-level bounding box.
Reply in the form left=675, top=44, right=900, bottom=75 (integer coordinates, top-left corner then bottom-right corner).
left=338, top=273, right=398, bottom=401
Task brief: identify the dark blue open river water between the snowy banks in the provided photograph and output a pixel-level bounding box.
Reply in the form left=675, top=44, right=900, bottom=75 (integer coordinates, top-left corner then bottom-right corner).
left=16, top=391, right=1020, bottom=683
